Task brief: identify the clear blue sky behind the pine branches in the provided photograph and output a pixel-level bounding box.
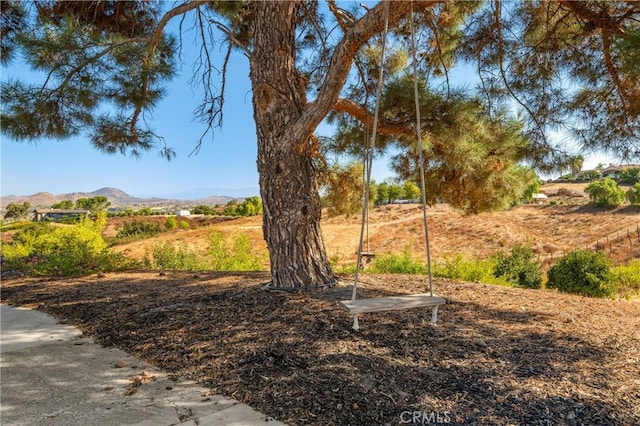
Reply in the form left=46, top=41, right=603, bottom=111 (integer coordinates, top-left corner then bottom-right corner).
left=0, top=10, right=613, bottom=198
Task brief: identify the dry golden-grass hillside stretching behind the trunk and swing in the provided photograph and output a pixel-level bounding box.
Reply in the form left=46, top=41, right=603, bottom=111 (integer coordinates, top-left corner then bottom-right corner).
left=108, top=200, right=640, bottom=263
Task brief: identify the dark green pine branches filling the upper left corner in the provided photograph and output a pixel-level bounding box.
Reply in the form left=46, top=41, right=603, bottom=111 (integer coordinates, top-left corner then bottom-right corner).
left=2, top=1, right=176, bottom=155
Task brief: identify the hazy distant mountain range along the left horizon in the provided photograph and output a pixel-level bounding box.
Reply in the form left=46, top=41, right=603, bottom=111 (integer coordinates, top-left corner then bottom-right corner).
left=0, top=187, right=240, bottom=209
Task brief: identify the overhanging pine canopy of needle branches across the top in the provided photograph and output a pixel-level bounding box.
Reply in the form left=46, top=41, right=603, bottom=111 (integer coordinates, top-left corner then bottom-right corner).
left=1, top=0, right=640, bottom=165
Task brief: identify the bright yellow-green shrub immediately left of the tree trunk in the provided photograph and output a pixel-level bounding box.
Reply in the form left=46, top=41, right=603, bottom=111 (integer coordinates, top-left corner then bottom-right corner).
left=208, top=230, right=266, bottom=271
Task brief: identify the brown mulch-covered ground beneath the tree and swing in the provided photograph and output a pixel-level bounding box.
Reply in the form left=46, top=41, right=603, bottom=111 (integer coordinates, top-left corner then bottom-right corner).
left=2, top=272, right=640, bottom=426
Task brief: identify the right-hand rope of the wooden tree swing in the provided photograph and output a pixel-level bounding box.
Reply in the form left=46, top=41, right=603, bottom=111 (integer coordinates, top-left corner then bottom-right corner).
left=409, top=1, right=433, bottom=297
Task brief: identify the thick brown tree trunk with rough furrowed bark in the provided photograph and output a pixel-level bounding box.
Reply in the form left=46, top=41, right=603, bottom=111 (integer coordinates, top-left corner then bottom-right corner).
left=250, top=1, right=335, bottom=288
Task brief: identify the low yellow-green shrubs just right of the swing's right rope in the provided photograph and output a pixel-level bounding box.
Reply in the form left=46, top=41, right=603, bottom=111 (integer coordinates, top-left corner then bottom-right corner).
left=433, top=254, right=511, bottom=286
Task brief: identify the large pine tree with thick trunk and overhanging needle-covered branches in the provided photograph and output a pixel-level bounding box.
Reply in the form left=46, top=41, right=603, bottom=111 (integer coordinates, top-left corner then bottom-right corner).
left=0, top=0, right=640, bottom=287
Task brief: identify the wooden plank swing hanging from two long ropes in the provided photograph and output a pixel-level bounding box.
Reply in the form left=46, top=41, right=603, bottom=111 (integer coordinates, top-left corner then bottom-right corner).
left=340, top=3, right=446, bottom=330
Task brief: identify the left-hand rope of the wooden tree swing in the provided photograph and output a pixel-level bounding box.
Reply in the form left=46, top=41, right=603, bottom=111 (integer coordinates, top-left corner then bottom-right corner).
left=351, top=3, right=389, bottom=316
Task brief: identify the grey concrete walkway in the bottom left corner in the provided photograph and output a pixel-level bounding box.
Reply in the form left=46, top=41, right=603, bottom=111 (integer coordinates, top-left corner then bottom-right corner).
left=0, top=305, right=284, bottom=426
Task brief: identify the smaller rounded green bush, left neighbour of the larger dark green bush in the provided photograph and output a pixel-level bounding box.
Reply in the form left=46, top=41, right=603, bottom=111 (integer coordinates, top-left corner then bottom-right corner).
left=493, top=246, right=542, bottom=288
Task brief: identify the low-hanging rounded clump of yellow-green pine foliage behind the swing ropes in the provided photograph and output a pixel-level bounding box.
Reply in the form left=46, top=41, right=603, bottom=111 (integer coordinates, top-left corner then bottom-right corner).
left=336, top=74, right=538, bottom=213
